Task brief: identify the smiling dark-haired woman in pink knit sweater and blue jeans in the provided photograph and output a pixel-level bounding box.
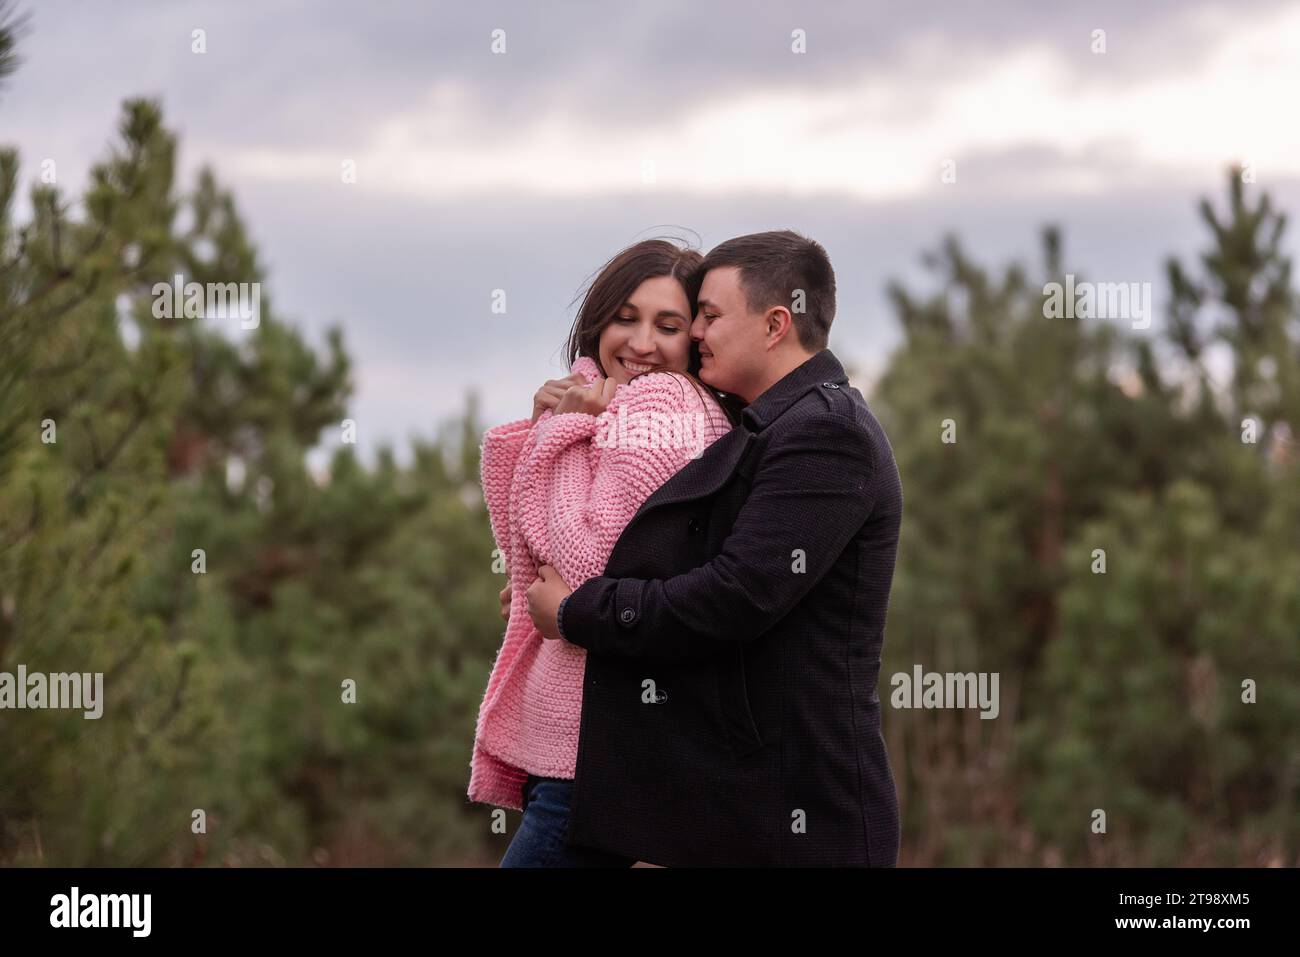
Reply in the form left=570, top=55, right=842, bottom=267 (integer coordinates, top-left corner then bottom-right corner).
left=469, top=239, right=737, bottom=867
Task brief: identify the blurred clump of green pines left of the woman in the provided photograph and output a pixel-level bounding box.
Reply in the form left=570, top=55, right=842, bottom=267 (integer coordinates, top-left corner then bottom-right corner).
left=0, top=89, right=499, bottom=865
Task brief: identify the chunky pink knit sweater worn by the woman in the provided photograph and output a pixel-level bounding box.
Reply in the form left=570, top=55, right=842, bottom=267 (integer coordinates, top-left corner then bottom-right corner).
left=469, top=356, right=731, bottom=810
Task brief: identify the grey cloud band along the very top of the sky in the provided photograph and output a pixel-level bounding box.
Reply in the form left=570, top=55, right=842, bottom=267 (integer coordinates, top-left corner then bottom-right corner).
left=0, top=0, right=1279, bottom=158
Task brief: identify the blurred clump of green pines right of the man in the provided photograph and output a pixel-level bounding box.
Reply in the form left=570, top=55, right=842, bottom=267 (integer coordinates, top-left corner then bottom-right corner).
left=872, top=172, right=1300, bottom=865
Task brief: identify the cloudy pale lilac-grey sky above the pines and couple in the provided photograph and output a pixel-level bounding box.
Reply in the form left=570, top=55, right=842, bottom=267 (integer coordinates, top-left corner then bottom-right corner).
left=0, top=0, right=1300, bottom=450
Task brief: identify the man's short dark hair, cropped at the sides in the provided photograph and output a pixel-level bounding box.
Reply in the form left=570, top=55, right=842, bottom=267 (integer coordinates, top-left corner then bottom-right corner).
left=696, top=229, right=835, bottom=352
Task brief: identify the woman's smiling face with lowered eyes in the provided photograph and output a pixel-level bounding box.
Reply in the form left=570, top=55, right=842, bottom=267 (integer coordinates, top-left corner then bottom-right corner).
left=598, top=276, right=690, bottom=385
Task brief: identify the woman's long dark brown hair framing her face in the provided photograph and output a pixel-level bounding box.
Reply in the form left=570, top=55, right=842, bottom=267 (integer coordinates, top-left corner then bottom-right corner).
left=567, top=239, right=745, bottom=425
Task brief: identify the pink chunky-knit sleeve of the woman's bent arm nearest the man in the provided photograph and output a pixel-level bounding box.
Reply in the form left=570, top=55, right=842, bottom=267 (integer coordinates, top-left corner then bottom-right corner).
left=519, top=373, right=703, bottom=585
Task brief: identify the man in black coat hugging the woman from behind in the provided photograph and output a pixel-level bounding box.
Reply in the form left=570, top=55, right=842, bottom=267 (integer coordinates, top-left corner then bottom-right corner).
left=528, top=231, right=902, bottom=866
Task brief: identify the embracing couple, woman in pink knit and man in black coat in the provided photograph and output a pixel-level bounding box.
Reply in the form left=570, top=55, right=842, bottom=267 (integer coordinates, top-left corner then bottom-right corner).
left=468, top=231, right=902, bottom=867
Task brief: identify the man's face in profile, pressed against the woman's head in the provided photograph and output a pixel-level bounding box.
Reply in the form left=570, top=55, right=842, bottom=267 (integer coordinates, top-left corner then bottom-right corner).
left=690, top=267, right=768, bottom=402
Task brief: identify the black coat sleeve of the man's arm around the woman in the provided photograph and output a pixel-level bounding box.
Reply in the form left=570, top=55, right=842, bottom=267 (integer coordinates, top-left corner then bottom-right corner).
left=559, top=415, right=878, bottom=661
